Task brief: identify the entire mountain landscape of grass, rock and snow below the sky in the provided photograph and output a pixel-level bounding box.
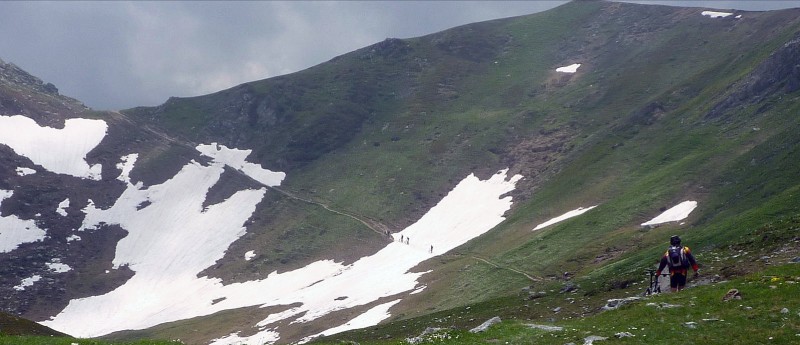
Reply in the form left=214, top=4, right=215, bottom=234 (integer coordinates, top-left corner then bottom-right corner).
left=0, top=1, right=800, bottom=345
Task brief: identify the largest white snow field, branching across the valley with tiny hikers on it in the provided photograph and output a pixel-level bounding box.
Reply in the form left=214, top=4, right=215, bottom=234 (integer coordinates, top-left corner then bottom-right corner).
left=43, top=166, right=521, bottom=344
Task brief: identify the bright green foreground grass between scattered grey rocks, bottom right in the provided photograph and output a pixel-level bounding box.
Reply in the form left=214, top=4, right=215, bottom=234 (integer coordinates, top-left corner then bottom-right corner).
left=314, top=264, right=800, bottom=344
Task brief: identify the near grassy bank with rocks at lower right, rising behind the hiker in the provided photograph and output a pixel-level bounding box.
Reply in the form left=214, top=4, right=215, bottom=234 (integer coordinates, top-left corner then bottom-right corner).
left=315, top=216, right=800, bottom=344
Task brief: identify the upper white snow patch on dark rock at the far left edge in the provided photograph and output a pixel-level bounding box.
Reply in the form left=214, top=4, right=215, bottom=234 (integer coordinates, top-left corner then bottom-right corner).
left=0, top=115, right=108, bottom=180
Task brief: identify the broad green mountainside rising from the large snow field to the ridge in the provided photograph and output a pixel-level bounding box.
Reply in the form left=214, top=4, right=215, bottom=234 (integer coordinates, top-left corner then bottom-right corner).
left=109, top=2, right=800, bottom=342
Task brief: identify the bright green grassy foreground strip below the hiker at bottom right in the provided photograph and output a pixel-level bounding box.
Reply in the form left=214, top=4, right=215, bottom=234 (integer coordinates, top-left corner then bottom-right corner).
left=316, top=264, right=800, bottom=344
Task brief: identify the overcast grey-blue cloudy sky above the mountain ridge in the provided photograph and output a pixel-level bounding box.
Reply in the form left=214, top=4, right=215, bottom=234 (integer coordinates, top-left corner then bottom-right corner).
left=0, top=0, right=800, bottom=110
